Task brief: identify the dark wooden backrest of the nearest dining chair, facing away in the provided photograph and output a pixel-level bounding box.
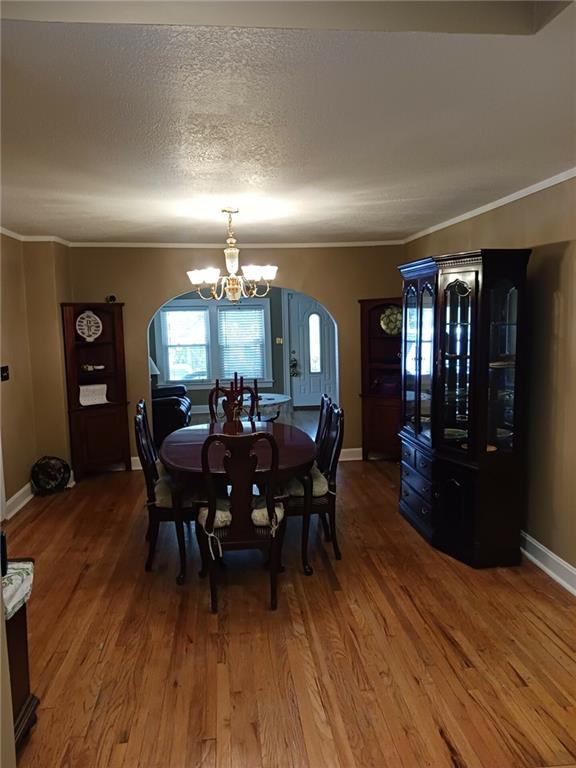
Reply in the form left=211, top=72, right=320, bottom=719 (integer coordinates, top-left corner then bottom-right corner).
left=202, top=432, right=278, bottom=543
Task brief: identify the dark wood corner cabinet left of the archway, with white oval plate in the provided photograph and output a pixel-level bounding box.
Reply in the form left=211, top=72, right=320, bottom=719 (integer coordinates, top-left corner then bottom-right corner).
left=62, top=303, right=130, bottom=480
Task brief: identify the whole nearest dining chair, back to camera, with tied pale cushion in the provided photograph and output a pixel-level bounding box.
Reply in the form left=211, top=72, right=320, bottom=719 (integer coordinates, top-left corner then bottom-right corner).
left=196, top=432, right=286, bottom=613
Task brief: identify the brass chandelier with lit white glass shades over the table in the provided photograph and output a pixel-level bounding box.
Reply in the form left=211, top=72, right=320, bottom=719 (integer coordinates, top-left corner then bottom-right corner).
left=187, top=208, right=278, bottom=302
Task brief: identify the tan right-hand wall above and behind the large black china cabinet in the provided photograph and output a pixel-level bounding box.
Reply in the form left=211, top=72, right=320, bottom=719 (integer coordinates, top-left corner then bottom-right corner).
left=406, top=179, right=576, bottom=565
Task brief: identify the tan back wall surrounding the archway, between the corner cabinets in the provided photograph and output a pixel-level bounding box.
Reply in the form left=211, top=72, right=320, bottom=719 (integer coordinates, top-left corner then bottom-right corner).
left=70, top=247, right=403, bottom=448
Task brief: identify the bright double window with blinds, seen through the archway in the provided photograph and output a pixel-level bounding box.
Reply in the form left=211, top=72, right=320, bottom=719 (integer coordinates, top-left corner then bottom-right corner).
left=154, top=299, right=273, bottom=389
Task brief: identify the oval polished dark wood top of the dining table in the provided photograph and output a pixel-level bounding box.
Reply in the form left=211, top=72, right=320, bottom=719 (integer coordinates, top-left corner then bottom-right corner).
left=160, top=421, right=316, bottom=474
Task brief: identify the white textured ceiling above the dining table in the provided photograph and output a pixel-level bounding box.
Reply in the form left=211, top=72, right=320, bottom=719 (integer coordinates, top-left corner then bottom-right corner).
left=2, top=4, right=576, bottom=245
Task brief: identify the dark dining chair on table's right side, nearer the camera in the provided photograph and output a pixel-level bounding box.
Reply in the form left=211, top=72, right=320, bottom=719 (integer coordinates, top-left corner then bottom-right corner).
left=284, top=403, right=344, bottom=560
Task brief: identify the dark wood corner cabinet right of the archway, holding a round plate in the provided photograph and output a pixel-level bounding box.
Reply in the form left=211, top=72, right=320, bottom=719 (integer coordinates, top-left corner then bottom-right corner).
left=360, top=298, right=402, bottom=461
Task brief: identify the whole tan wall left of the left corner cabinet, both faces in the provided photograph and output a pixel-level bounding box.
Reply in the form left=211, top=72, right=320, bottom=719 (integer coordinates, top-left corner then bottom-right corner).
left=1, top=235, right=71, bottom=498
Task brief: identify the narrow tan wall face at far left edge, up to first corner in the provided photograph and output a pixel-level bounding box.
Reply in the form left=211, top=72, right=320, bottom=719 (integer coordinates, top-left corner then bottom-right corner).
left=0, top=235, right=36, bottom=498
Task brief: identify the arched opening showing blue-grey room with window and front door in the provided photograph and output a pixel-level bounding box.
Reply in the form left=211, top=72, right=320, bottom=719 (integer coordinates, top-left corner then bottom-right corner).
left=148, top=287, right=338, bottom=433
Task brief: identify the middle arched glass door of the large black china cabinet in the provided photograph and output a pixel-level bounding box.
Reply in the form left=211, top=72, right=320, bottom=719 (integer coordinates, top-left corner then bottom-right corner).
left=441, top=273, right=475, bottom=450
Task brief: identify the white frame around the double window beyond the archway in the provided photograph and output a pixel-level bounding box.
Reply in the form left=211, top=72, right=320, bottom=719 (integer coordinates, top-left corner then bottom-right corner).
left=154, top=298, right=274, bottom=390
